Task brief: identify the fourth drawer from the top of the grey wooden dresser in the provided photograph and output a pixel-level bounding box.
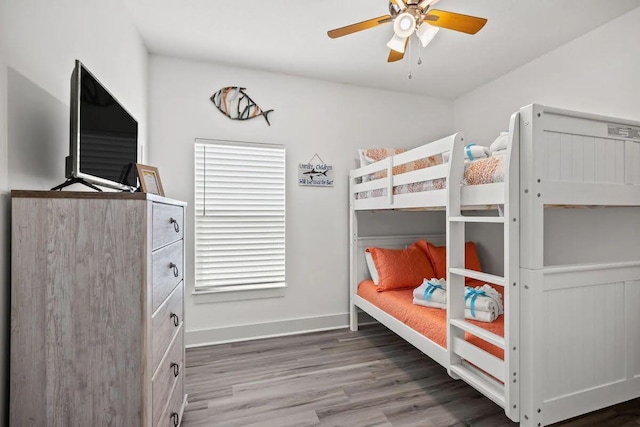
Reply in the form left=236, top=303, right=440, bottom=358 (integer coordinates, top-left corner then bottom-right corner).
left=151, top=329, right=184, bottom=425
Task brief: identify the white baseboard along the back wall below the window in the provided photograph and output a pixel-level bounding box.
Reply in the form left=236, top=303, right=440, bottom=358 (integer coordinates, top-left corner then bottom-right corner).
left=185, top=312, right=374, bottom=348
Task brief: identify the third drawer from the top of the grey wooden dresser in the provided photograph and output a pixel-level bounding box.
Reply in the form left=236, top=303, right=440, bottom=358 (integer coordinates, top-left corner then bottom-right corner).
left=151, top=281, right=184, bottom=372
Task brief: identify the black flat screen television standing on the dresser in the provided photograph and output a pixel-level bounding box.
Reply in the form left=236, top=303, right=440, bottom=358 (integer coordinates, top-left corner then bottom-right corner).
left=56, top=60, right=138, bottom=191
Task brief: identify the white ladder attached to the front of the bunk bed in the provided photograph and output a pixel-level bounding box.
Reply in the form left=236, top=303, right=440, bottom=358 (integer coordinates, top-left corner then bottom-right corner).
left=446, top=113, right=520, bottom=421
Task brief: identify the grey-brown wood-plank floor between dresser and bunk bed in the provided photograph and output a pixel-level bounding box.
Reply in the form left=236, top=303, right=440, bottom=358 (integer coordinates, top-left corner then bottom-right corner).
left=182, top=325, right=640, bottom=427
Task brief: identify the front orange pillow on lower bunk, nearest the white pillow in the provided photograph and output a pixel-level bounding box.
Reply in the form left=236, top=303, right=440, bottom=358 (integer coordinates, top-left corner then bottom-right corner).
left=367, top=244, right=435, bottom=292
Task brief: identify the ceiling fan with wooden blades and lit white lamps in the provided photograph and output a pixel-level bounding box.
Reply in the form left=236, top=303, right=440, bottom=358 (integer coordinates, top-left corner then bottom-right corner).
left=327, top=0, right=487, bottom=62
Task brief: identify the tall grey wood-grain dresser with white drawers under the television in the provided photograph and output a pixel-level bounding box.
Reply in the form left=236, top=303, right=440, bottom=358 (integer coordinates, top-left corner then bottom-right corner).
left=10, top=191, right=186, bottom=427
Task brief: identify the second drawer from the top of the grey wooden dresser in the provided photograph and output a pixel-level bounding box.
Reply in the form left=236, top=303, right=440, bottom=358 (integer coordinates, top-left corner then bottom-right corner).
left=151, top=240, right=184, bottom=312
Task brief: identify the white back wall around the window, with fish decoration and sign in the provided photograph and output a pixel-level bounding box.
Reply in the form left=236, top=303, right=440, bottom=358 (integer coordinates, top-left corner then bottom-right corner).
left=148, top=56, right=453, bottom=344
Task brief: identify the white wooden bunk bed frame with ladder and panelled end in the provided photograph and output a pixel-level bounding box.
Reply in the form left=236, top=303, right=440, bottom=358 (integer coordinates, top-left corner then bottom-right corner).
left=350, top=105, right=640, bottom=426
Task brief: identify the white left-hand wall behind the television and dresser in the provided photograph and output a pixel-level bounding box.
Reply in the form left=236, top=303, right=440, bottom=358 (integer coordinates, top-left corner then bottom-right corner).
left=0, top=0, right=148, bottom=425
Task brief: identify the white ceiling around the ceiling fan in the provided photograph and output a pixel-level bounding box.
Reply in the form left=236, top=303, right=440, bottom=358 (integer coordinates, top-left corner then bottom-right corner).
left=123, top=0, right=640, bottom=99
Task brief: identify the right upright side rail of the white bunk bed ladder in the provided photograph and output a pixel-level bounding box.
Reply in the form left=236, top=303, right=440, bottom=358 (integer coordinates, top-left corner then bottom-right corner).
left=503, top=112, right=522, bottom=422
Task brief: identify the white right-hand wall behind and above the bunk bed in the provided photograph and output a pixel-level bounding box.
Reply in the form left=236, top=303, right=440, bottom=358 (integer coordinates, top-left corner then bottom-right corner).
left=454, top=8, right=640, bottom=274
